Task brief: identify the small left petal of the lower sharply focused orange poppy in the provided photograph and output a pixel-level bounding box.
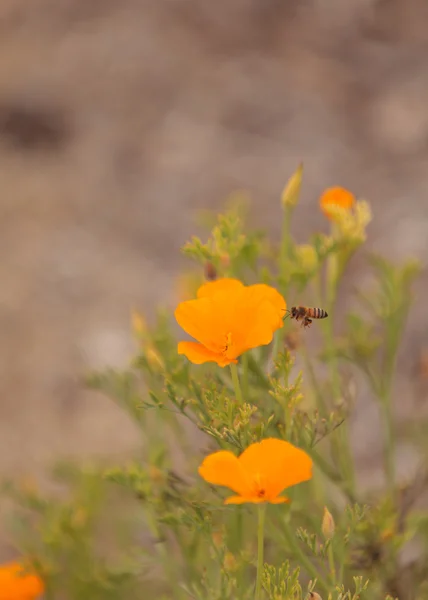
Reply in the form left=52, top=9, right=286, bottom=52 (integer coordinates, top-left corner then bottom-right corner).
left=198, top=450, right=251, bottom=497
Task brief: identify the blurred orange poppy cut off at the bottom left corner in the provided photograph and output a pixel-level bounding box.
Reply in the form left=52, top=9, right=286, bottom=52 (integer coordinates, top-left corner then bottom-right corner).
left=0, top=562, right=45, bottom=600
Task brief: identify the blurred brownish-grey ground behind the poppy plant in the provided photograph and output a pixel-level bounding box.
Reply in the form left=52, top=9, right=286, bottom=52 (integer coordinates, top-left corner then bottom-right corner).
left=0, top=0, right=428, bottom=524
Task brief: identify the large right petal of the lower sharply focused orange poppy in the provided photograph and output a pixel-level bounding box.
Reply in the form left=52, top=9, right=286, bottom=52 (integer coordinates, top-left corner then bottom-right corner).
left=238, top=438, right=312, bottom=502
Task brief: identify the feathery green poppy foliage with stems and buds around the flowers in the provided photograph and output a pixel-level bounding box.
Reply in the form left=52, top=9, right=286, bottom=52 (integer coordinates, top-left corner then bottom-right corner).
left=4, top=168, right=428, bottom=600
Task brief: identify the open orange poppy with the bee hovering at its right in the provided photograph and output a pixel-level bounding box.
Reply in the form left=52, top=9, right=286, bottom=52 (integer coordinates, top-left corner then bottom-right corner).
left=175, top=279, right=286, bottom=367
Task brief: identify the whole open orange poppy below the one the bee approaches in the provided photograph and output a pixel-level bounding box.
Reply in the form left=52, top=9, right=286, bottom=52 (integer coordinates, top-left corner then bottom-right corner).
left=199, top=438, right=312, bottom=504
